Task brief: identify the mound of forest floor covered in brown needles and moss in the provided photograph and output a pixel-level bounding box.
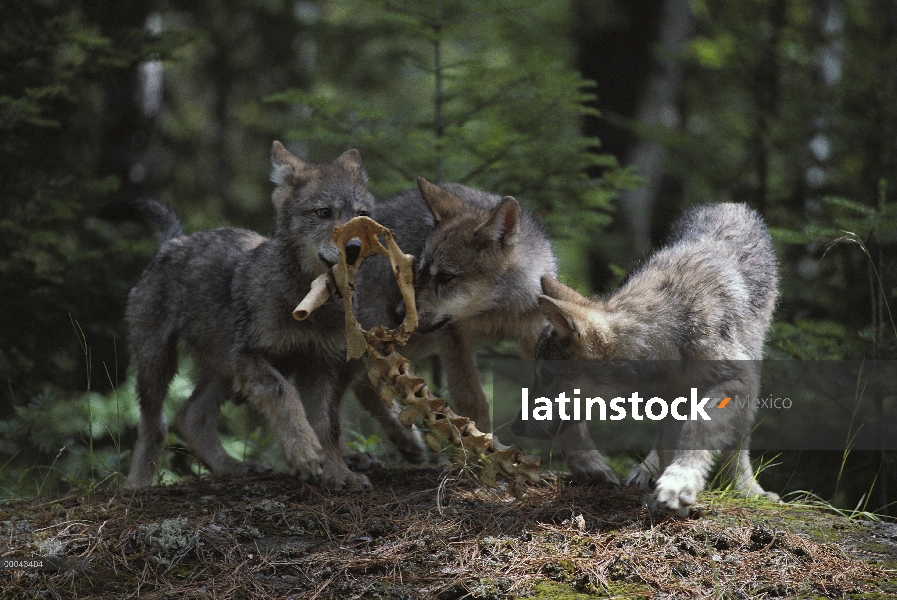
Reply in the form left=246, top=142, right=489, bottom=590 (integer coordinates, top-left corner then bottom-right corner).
left=0, top=468, right=897, bottom=600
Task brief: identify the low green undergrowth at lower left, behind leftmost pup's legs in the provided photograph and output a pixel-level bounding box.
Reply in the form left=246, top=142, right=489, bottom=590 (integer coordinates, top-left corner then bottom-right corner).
left=0, top=361, right=290, bottom=498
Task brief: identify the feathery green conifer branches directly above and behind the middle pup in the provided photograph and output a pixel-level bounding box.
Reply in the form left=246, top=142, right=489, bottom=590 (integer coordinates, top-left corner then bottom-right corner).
left=269, top=0, right=636, bottom=241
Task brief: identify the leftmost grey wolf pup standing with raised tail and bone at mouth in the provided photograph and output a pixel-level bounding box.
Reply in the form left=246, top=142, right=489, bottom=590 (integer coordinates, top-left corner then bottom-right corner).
left=126, top=141, right=374, bottom=488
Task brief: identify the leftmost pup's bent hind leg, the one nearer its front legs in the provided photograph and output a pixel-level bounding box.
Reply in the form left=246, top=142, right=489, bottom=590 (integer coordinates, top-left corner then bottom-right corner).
left=175, top=375, right=269, bottom=477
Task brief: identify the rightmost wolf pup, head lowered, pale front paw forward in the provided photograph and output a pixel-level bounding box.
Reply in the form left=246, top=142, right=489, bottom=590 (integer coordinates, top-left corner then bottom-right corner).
left=536, top=204, right=778, bottom=513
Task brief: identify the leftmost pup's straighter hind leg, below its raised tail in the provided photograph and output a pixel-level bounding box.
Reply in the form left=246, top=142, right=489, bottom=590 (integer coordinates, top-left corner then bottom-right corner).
left=125, top=337, right=177, bottom=489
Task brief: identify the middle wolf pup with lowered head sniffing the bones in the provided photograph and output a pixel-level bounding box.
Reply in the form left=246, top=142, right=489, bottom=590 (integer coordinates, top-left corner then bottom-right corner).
left=344, top=178, right=612, bottom=480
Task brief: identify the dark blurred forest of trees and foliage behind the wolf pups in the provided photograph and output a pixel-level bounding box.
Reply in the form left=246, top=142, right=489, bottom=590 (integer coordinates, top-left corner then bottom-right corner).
left=0, top=0, right=897, bottom=514
